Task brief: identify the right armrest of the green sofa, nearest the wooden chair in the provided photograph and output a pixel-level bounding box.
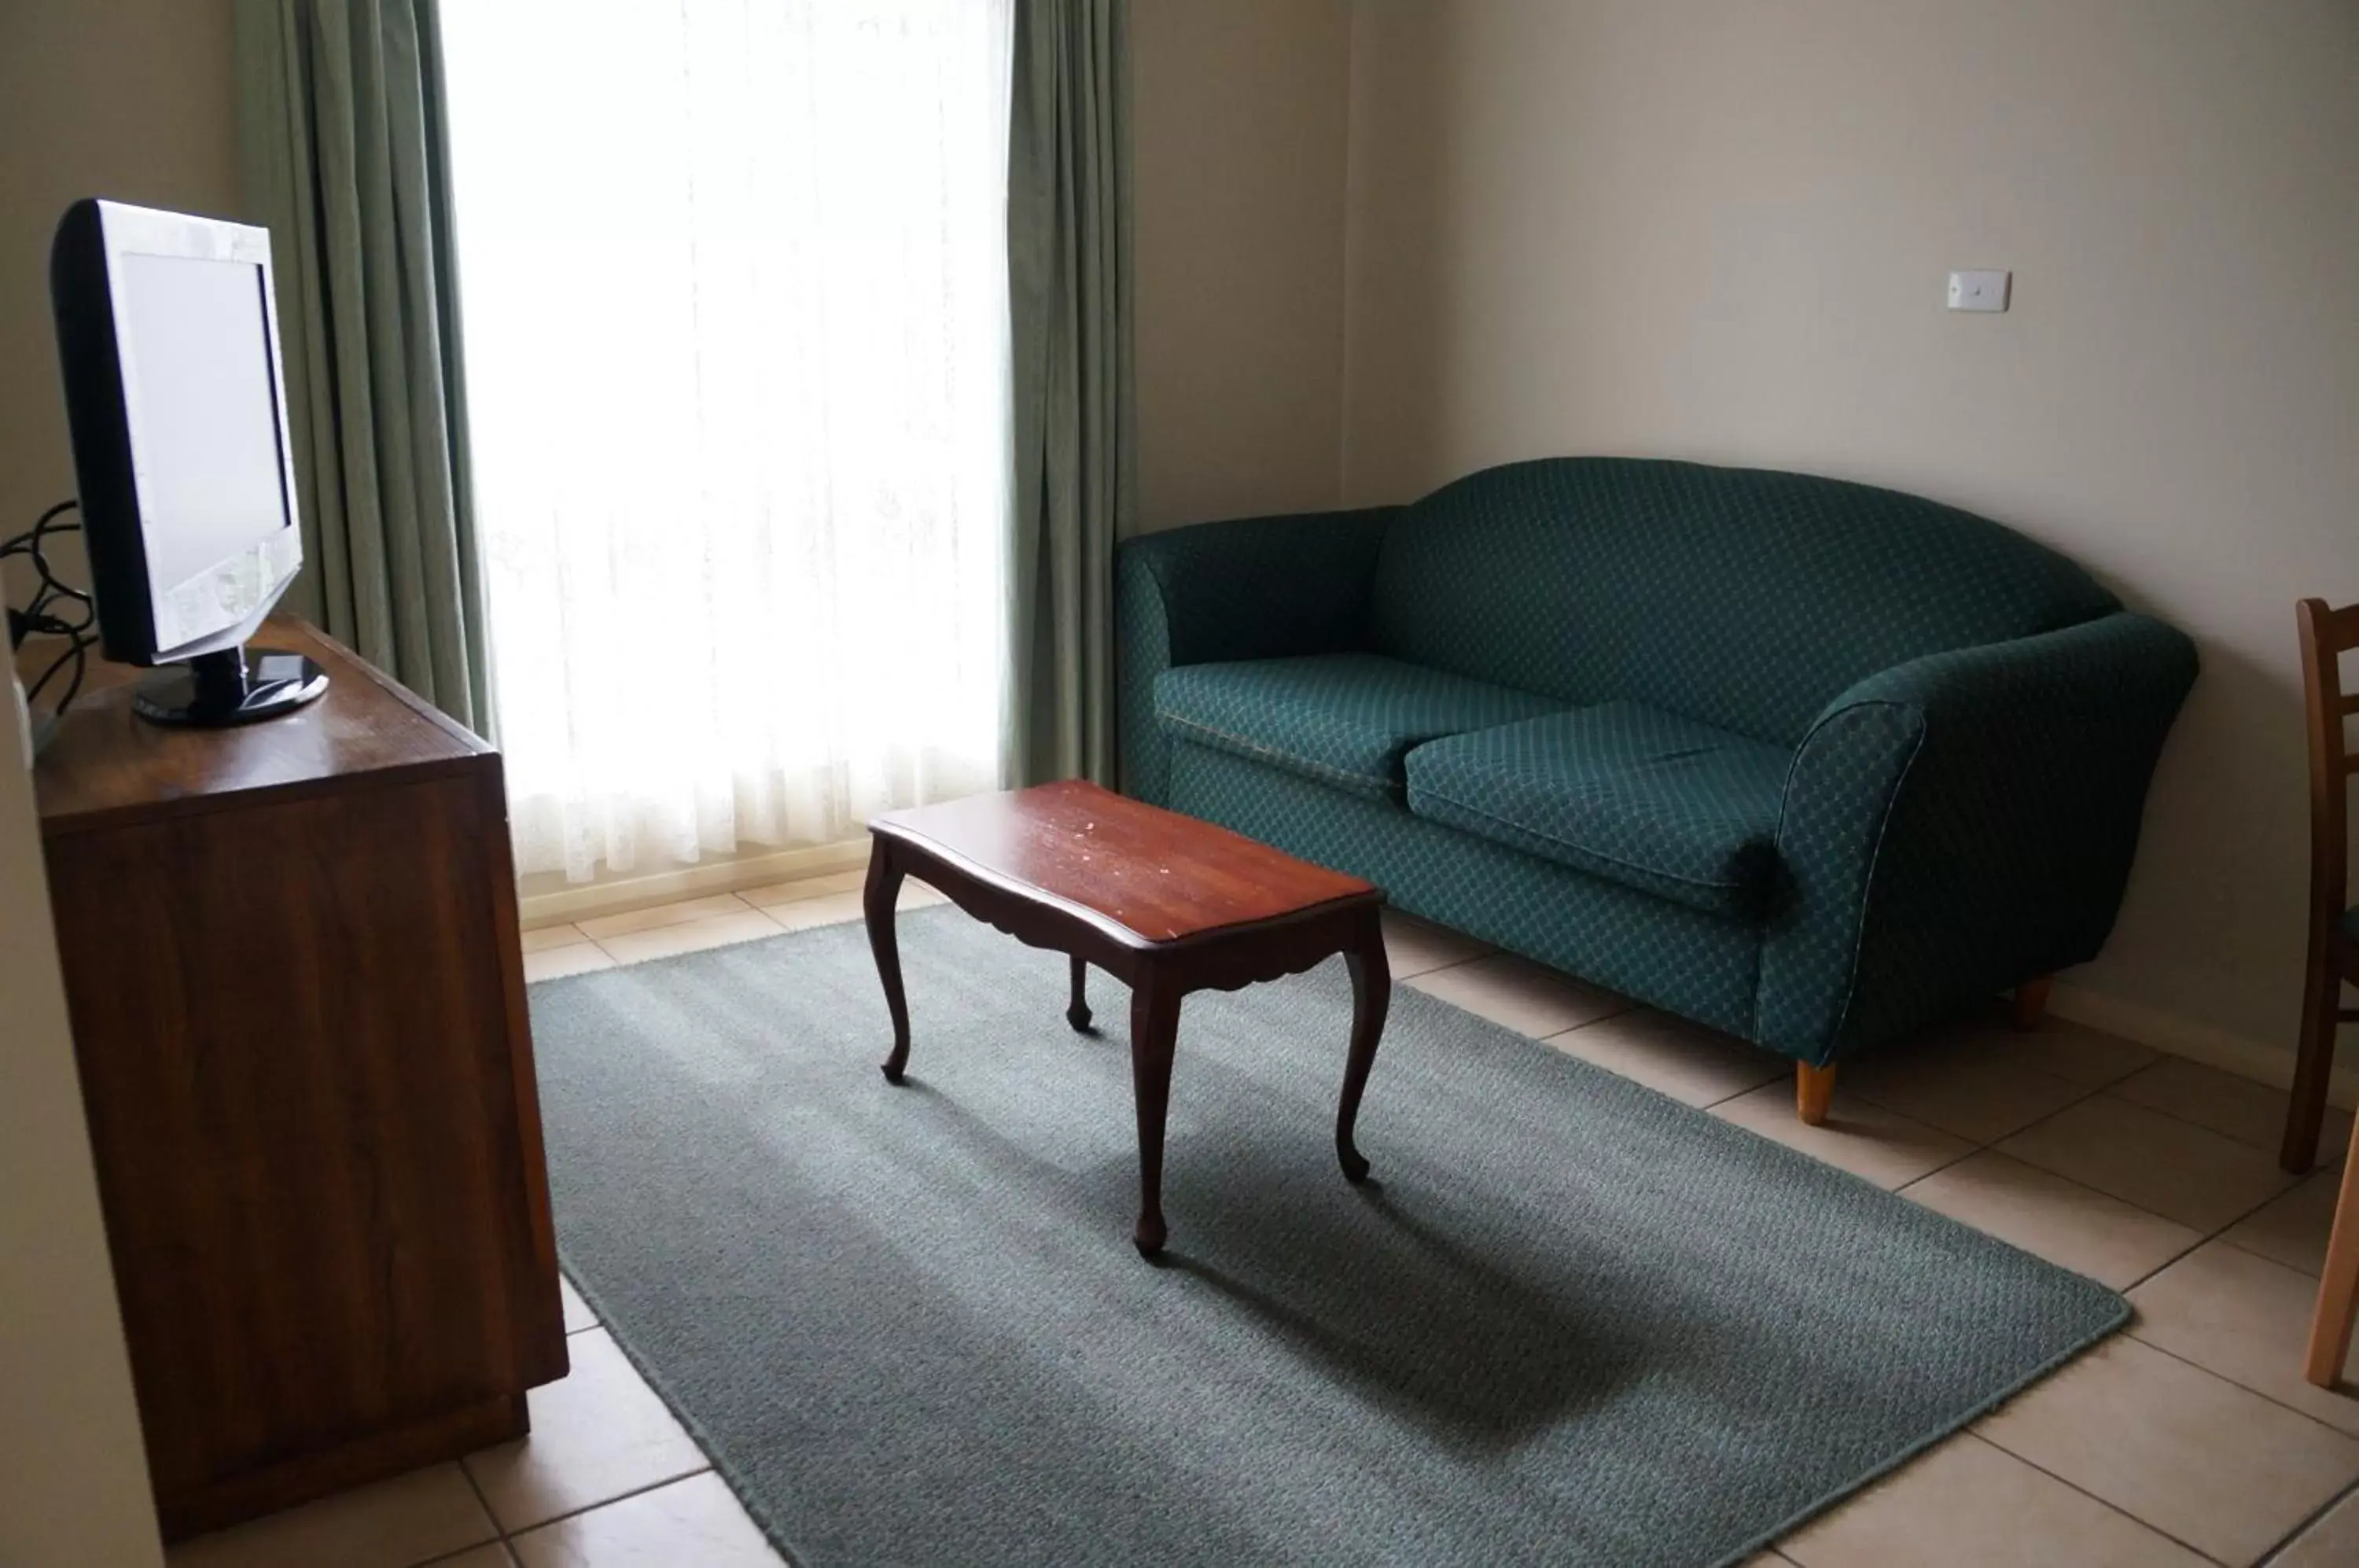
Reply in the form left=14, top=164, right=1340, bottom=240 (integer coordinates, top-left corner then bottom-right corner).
left=1755, top=611, right=2196, bottom=1063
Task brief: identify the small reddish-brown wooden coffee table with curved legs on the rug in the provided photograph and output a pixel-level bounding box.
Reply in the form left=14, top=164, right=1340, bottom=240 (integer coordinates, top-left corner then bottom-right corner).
left=863, top=781, right=1392, bottom=1257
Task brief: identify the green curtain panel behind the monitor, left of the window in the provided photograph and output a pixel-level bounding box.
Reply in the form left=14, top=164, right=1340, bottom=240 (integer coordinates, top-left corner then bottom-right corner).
left=236, top=0, right=491, bottom=731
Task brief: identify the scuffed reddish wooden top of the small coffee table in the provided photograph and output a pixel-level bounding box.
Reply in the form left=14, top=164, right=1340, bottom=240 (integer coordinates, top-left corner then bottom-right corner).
left=868, top=778, right=1385, bottom=943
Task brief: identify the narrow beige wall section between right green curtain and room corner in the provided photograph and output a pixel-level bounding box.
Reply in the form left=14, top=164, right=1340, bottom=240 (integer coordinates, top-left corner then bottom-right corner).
left=1132, top=0, right=1349, bottom=528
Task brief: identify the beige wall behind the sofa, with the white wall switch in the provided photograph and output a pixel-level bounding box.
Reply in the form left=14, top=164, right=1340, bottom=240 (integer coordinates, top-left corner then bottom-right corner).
left=1345, top=0, right=2359, bottom=1047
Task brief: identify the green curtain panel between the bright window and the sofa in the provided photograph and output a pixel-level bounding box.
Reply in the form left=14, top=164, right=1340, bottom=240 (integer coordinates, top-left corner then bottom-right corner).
left=1007, top=0, right=1137, bottom=785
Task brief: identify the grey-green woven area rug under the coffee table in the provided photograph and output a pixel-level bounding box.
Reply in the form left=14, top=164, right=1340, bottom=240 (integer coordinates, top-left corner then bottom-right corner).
left=533, top=907, right=2128, bottom=1568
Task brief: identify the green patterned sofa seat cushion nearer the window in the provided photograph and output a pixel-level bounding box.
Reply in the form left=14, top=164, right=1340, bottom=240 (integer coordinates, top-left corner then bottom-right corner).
left=1156, top=653, right=1562, bottom=799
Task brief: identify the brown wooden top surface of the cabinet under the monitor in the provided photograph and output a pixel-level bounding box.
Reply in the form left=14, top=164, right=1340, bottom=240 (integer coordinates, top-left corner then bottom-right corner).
left=33, top=616, right=491, bottom=832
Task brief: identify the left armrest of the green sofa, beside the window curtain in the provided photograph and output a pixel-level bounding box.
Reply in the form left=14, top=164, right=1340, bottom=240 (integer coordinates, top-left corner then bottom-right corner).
left=1113, top=507, right=1399, bottom=804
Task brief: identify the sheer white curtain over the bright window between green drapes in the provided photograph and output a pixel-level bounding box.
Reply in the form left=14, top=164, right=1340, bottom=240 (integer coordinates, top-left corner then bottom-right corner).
left=441, top=0, right=1010, bottom=879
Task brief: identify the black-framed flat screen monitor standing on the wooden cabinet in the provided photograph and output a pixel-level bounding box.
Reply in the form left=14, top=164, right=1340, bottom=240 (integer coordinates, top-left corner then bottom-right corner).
left=50, top=201, right=323, bottom=722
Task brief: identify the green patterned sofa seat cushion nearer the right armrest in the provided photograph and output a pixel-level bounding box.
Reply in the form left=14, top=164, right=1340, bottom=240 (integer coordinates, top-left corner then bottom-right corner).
left=1406, top=703, right=1793, bottom=917
